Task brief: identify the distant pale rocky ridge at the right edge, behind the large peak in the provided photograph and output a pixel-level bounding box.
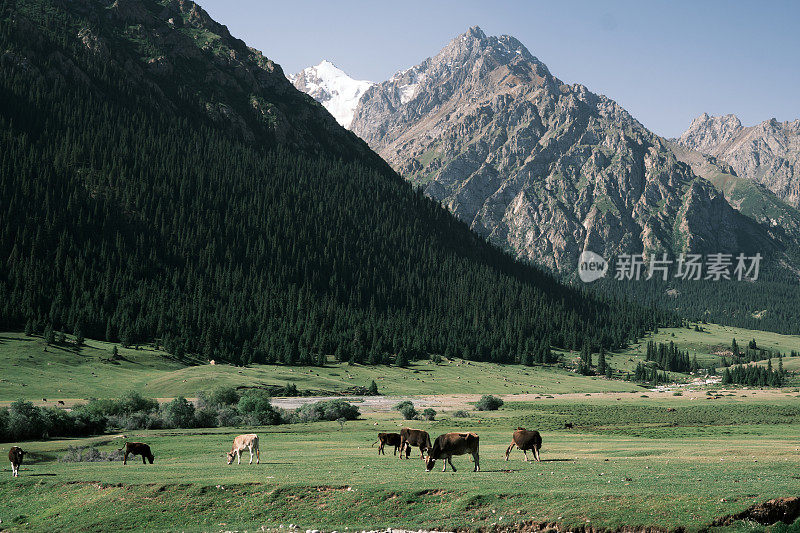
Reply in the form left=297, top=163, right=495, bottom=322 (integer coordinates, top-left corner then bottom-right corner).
left=677, top=113, right=800, bottom=207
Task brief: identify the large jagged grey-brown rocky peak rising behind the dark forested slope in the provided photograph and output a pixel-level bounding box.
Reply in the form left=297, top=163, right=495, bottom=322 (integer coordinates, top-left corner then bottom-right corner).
left=352, top=27, right=759, bottom=272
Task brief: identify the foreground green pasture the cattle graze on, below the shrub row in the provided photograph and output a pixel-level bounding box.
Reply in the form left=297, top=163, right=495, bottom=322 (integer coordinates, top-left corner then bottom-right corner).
left=0, top=394, right=800, bottom=531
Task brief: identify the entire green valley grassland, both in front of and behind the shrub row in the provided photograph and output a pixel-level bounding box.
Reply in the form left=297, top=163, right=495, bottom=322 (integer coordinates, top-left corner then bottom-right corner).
left=0, top=325, right=800, bottom=533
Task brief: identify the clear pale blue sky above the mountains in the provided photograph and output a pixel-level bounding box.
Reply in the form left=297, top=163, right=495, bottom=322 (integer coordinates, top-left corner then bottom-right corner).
left=200, top=0, right=800, bottom=137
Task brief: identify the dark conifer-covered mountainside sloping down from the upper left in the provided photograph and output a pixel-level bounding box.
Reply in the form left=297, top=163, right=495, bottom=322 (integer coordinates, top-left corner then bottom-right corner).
left=0, top=0, right=672, bottom=363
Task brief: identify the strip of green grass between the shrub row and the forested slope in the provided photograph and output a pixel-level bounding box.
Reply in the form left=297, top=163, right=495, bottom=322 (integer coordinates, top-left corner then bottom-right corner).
left=0, top=324, right=800, bottom=403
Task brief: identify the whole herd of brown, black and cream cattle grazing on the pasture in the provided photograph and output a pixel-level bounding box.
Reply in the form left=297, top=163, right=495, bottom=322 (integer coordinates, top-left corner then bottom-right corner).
left=8, top=428, right=542, bottom=477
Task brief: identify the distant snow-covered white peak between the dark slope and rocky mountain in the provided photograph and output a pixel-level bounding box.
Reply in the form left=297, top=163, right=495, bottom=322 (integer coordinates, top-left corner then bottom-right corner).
left=287, top=59, right=375, bottom=129
